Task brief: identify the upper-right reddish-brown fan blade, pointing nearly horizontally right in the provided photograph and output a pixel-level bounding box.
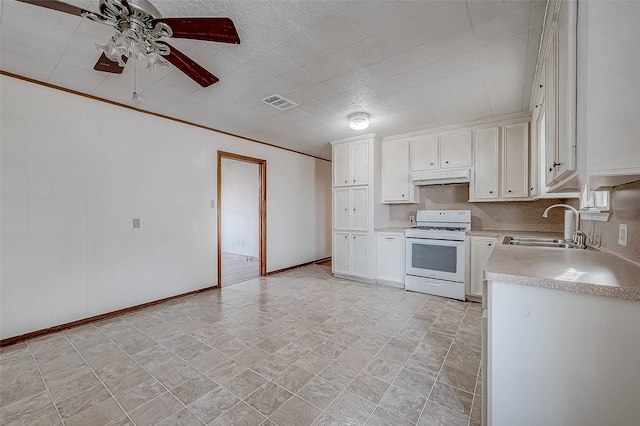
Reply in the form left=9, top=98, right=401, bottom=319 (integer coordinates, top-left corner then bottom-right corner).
left=152, top=18, right=240, bottom=44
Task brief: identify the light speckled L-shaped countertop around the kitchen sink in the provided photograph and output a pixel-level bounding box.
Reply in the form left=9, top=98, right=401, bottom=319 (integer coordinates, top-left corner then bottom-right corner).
left=484, top=230, right=640, bottom=301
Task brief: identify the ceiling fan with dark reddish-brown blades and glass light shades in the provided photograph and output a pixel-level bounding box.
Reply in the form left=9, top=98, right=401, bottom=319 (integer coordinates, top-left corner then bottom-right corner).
left=18, top=0, right=240, bottom=87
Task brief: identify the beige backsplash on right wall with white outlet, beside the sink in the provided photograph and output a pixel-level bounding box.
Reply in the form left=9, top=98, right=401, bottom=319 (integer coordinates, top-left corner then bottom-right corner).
left=580, top=181, right=640, bottom=263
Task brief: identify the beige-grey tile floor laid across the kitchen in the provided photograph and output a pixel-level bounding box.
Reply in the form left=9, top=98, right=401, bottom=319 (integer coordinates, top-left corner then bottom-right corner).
left=0, top=265, right=481, bottom=426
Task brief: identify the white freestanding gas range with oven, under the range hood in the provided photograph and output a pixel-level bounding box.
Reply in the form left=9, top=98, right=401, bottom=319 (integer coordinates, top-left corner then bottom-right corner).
left=404, top=210, right=471, bottom=300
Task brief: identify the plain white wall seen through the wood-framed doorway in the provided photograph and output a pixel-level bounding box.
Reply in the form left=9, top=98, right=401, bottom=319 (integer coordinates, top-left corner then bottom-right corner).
left=220, top=158, right=260, bottom=257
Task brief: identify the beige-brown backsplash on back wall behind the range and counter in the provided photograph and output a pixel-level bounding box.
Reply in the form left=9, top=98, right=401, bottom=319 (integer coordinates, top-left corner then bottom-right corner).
left=389, top=183, right=578, bottom=232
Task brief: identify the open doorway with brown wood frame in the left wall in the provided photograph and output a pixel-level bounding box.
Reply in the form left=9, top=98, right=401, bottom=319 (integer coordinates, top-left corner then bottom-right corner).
left=218, top=151, right=267, bottom=287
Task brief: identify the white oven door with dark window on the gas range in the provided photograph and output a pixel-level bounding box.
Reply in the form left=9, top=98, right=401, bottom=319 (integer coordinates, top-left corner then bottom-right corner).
left=406, top=238, right=465, bottom=282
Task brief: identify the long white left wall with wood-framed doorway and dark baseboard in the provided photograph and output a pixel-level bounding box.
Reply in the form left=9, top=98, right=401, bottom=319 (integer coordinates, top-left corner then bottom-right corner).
left=0, top=76, right=331, bottom=338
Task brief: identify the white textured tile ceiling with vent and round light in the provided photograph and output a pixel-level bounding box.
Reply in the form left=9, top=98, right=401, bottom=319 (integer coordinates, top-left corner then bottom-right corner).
left=0, top=0, right=546, bottom=158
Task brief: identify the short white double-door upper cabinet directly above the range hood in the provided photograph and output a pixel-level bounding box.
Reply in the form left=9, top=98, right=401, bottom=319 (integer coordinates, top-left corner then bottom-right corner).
left=411, top=131, right=471, bottom=172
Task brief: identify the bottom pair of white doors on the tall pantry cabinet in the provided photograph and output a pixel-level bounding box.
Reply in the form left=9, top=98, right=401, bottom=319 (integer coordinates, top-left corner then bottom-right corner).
left=331, top=232, right=371, bottom=278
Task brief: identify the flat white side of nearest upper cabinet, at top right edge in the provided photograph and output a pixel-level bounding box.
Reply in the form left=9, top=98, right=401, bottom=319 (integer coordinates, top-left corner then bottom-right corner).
left=578, top=1, right=640, bottom=190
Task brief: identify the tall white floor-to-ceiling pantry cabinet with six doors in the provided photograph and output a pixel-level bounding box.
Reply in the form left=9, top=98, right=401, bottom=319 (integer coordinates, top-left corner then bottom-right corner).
left=331, top=134, right=389, bottom=281
